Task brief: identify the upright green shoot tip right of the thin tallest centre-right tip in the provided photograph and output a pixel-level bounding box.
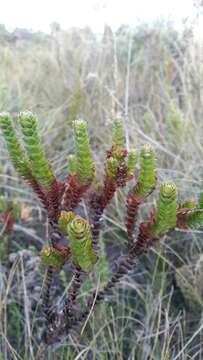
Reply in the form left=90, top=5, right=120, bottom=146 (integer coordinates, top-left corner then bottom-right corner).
left=136, top=144, right=156, bottom=194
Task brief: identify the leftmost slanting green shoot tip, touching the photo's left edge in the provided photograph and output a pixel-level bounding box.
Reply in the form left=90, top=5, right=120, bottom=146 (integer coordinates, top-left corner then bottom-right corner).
left=0, top=112, right=30, bottom=177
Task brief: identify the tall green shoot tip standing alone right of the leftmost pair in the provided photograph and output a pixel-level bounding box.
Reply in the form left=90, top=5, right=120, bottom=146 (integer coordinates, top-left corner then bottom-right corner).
left=73, top=120, right=94, bottom=185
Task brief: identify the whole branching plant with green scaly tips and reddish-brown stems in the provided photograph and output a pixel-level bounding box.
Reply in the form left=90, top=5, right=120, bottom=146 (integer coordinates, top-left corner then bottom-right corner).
left=0, top=111, right=203, bottom=358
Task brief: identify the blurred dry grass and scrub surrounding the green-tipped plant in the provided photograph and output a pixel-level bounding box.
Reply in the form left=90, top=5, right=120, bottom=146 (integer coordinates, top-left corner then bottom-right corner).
left=0, top=23, right=203, bottom=360
